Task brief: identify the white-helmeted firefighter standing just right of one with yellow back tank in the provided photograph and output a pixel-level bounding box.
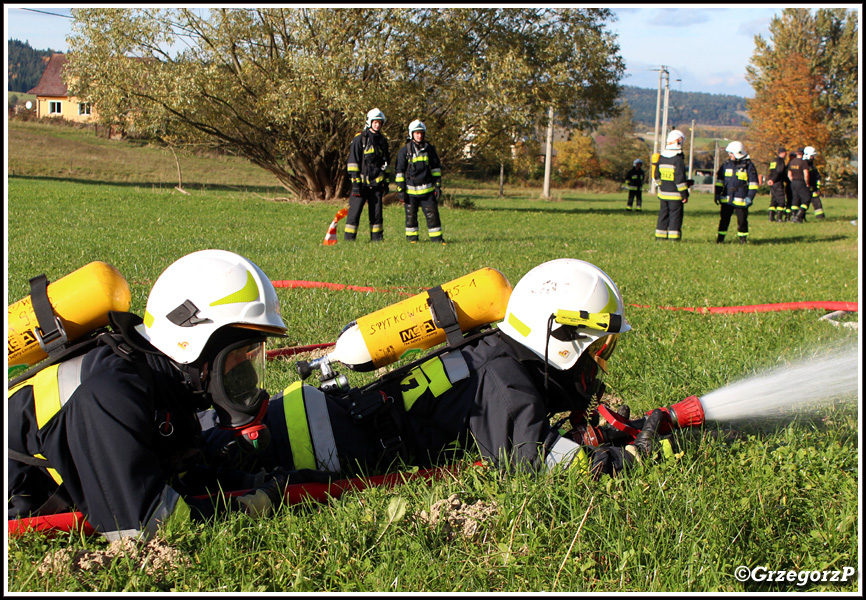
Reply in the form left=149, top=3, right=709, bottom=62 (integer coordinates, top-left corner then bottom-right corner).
left=714, top=142, right=758, bottom=244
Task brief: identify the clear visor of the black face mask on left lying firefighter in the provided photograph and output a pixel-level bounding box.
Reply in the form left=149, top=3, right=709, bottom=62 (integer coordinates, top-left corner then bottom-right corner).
left=214, top=340, right=265, bottom=412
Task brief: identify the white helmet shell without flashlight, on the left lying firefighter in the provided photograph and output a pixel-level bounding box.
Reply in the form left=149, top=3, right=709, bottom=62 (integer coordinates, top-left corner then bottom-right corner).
left=136, top=250, right=286, bottom=364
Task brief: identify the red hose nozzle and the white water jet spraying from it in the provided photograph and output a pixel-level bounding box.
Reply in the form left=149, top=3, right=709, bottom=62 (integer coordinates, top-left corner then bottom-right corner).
left=575, top=348, right=860, bottom=446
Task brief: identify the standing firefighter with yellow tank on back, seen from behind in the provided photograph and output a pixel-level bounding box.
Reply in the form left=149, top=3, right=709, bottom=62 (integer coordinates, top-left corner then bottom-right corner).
left=653, top=129, right=689, bottom=242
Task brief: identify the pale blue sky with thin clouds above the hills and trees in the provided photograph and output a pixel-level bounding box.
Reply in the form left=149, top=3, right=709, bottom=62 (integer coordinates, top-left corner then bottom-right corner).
left=4, top=3, right=861, bottom=98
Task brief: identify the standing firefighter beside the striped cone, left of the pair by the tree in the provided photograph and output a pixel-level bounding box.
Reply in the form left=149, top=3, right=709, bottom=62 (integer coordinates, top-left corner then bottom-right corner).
left=343, top=108, right=391, bottom=242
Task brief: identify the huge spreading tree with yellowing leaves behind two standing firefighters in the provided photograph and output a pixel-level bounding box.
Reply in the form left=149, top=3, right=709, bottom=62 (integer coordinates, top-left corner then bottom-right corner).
left=67, top=8, right=624, bottom=200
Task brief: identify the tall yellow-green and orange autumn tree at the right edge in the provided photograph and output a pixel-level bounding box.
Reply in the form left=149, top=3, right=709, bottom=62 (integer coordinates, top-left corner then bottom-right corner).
left=746, top=8, right=859, bottom=192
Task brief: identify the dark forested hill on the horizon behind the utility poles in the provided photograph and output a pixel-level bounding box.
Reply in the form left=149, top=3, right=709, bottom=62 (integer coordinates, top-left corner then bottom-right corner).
left=620, top=85, right=749, bottom=129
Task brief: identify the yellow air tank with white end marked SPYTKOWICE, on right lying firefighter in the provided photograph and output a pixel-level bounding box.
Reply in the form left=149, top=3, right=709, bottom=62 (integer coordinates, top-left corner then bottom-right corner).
left=328, top=267, right=511, bottom=371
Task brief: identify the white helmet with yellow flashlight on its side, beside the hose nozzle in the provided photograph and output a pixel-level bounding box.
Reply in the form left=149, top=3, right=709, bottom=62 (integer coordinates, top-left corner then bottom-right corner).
left=499, top=258, right=631, bottom=371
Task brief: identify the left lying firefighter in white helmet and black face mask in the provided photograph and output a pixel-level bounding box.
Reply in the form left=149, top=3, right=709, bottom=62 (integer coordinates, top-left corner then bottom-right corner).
left=7, top=250, right=294, bottom=540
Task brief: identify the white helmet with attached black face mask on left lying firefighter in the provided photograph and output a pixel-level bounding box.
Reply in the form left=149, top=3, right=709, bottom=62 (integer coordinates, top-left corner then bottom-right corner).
left=135, top=250, right=286, bottom=440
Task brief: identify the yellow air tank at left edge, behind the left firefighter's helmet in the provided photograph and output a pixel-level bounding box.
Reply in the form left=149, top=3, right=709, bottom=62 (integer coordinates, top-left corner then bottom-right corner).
left=6, top=261, right=132, bottom=366
